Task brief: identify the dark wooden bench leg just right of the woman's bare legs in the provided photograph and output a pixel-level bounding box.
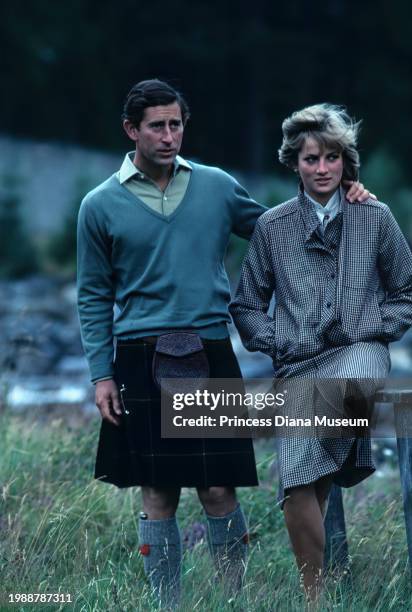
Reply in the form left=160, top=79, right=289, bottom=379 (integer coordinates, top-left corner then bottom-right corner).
left=324, top=485, right=349, bottom=571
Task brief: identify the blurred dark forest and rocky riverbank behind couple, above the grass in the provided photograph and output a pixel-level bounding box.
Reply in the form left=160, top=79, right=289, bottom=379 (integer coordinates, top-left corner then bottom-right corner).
left=0, top=0, right=412, bottom=410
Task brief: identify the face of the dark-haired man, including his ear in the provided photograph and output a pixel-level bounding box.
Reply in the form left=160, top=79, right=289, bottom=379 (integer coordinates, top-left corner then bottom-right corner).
left=125, top=102, right=184, bottom=167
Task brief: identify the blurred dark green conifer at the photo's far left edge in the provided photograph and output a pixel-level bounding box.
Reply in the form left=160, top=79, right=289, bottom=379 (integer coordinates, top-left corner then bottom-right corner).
left=0, top=176, right=38, bottom=278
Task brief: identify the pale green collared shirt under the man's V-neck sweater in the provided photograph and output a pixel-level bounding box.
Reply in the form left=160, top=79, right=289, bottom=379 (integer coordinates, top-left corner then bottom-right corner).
left=117, top=151, right=192, bottom=217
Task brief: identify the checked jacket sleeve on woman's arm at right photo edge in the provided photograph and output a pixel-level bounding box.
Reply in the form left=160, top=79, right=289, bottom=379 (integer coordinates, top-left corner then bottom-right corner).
left=379, top=207, right=412, bottom=342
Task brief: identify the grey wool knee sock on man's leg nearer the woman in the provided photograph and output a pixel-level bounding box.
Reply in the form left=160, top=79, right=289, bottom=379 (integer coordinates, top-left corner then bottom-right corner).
left=206, top=504, right=249, bottom=594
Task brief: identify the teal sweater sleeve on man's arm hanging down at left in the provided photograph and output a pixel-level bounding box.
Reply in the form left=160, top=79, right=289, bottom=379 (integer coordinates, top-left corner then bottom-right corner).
left=77, top=196, right=114, bottom=382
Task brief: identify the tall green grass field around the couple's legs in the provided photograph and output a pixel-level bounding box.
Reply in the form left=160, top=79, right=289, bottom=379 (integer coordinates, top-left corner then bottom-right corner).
left=0, top=410, right=412, bottom=612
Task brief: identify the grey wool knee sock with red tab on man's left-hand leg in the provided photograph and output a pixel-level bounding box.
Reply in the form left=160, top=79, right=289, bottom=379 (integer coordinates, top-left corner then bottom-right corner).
left=139, top=517, right=182, bottom=609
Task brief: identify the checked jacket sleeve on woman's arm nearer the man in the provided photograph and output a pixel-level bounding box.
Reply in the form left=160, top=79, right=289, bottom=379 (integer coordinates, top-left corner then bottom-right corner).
left=230, top=219, right=276, bottom=357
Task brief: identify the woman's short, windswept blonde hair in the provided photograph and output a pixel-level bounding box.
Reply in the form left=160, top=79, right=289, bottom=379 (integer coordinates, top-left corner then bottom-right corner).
left=279, top=104, right=360, bottom=181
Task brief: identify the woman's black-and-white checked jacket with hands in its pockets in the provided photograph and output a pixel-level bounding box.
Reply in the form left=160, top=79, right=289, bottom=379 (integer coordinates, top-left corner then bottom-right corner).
left=230, top=191, right=412, bottom=369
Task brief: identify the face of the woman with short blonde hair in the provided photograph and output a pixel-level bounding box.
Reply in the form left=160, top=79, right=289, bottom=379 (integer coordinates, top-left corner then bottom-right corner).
left=297, top=137, right=343, bottom=204
